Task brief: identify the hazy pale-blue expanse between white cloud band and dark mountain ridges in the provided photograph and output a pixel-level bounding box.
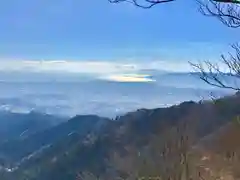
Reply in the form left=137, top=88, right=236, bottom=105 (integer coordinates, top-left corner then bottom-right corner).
left=0, top=70, right=232, bottom=117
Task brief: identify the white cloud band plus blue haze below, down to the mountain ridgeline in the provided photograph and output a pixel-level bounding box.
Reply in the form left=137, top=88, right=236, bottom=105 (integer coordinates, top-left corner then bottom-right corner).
left=0, top=60, right=233, bottom=116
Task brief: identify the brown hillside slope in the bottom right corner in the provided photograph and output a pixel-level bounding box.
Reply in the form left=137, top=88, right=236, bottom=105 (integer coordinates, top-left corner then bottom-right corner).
left=192, top=120, right=240, bottom=180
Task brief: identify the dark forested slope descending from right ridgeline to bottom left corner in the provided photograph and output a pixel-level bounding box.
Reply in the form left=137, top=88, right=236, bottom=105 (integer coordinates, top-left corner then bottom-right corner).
left=1, top=92, right=240, bottom=180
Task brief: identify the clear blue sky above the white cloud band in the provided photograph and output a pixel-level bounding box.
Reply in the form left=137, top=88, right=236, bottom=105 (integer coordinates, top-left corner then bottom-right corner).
left=0, top=0, right=238, bottom=73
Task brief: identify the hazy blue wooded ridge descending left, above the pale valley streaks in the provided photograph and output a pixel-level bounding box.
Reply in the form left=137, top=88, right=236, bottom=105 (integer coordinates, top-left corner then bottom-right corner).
left=0, top=115, right=108, bottom=167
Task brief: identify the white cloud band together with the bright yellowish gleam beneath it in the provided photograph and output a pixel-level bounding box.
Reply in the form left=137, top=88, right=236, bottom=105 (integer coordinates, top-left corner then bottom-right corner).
left=0, top=59, right=229, bottom=82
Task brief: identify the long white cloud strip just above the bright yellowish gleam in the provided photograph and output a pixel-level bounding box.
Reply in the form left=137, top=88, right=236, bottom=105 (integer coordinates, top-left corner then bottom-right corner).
left=0, top=60, right=189, bottom=75
